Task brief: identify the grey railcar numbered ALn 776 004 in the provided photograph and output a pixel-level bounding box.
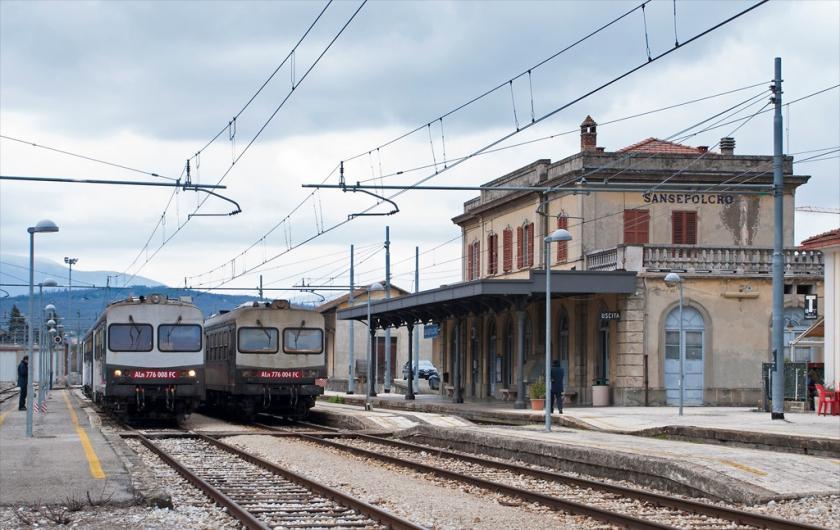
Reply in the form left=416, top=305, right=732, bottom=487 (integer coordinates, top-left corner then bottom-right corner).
left=204, top=300, right=327, bottom=419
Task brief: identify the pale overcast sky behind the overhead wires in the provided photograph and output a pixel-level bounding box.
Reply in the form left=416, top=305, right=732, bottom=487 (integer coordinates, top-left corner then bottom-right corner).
left=0, top=0, right=840, bottom=296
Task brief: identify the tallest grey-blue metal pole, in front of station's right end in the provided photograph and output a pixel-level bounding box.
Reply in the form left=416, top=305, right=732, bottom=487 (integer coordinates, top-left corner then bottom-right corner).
left=770, top=57, right=785, bottom=420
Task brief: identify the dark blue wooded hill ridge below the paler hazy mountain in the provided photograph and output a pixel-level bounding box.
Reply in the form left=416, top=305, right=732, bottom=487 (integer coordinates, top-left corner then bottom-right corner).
left=0, top=284, right=257, bottom=333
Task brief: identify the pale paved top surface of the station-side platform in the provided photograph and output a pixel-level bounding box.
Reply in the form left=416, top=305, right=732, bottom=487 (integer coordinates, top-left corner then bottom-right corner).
left=317, top=388, right=840, bottom=499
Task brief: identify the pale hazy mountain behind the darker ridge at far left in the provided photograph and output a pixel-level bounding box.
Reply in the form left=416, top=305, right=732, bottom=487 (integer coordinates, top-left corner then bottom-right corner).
left=0, top=254, right=163, bottom=296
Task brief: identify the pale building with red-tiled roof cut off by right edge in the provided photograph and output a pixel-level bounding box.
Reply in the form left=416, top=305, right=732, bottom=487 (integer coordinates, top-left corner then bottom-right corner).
left=801, top=228, right=840, bottom=388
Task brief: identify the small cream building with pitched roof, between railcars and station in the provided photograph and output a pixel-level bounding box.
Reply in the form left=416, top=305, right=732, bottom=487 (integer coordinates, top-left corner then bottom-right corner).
left=317, top=284, right=436, bottom=392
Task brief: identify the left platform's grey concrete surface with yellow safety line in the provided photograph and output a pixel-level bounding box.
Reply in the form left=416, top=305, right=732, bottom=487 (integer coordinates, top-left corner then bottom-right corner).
left=0, top=390, right=134, bottom=505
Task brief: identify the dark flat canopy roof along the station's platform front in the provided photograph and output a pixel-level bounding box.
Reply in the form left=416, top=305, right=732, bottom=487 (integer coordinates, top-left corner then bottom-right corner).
left=337, top=270, right=636, bottom=327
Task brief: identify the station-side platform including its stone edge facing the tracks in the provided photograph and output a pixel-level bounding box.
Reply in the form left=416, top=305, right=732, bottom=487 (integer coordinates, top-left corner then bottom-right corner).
left=314, top=394, right=840, bottom=503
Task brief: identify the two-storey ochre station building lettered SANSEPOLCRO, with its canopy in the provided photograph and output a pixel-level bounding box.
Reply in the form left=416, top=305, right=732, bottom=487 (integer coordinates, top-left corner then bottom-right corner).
left=338, top=116, right=823, bottom=407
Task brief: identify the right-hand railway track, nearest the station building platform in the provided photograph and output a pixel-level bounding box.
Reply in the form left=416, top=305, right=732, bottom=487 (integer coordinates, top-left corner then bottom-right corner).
left=264, top=424, right=818, bottom=530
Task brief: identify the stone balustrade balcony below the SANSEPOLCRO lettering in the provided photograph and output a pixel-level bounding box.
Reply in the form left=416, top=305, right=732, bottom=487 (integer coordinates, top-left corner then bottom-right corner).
left=586, top=245, right=824, bottom=276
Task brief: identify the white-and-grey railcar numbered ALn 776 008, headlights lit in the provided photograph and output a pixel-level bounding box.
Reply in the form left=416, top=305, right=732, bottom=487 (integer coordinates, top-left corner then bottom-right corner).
left=83, top=294, right=204, bottom=421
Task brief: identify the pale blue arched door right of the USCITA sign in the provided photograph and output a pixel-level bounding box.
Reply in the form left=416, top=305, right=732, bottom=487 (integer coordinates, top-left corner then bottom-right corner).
left=665, top=306, right=706, bottom=405
